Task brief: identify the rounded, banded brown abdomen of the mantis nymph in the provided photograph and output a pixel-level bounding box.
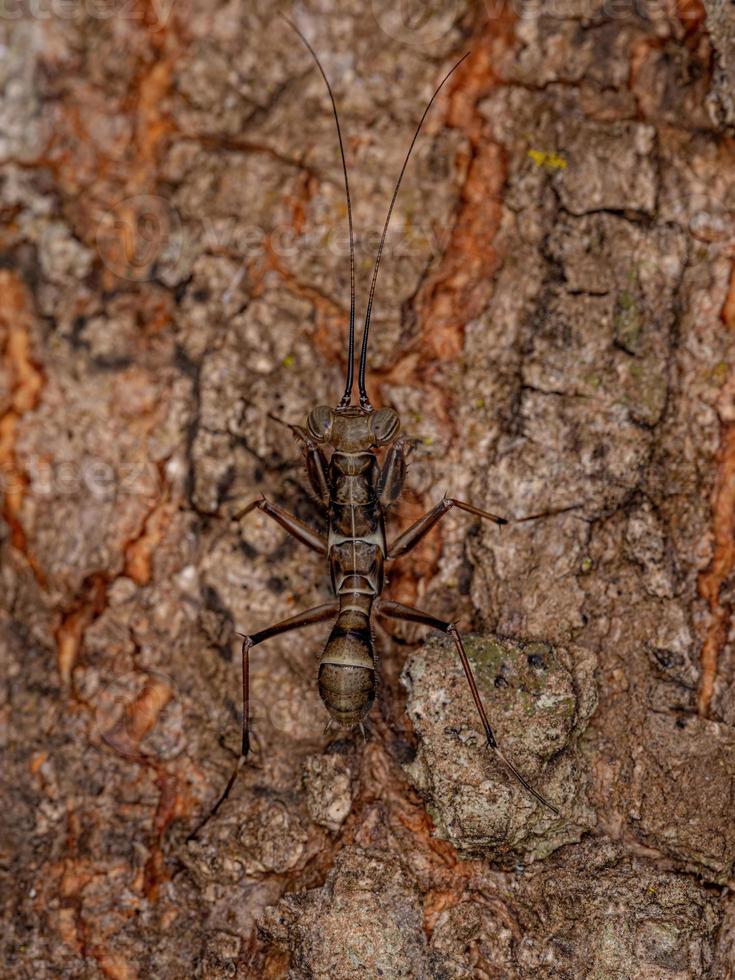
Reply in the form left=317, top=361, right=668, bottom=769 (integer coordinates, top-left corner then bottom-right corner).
left=319, top=610, right=375, bottom=728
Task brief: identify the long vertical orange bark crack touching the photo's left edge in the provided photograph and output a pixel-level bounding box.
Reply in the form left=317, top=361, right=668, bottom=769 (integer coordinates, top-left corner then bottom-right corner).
left=0, top=270, right=45, bottom=585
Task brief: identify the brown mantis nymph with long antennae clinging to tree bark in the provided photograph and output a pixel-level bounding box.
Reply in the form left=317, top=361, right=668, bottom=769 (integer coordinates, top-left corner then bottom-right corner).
left=190, top=18, right=559, bottom=837
